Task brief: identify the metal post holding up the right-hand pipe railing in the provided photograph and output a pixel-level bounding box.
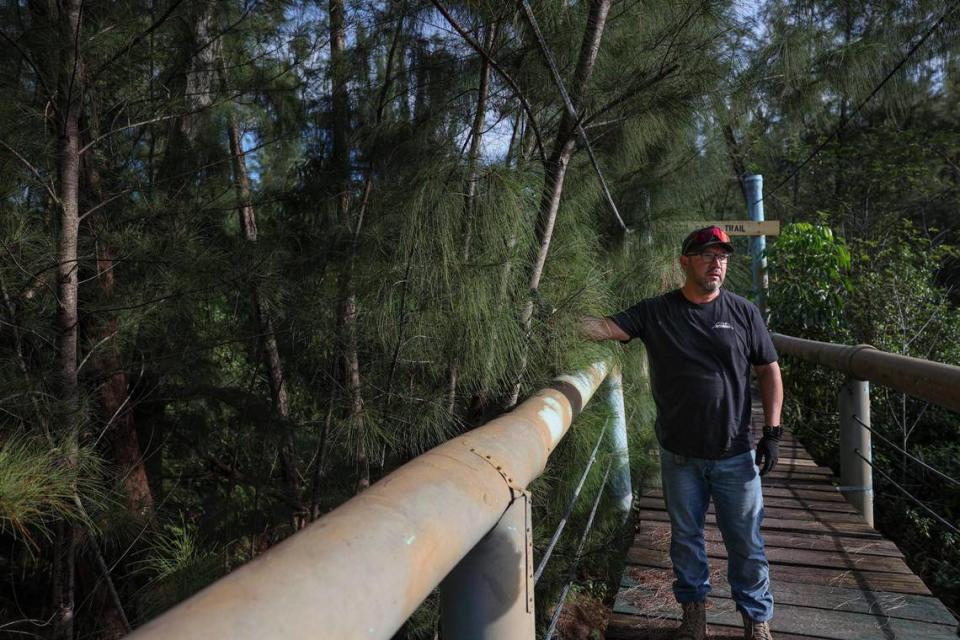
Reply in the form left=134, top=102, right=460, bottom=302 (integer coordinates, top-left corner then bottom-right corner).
left=837, top=378, right=873, bottom=527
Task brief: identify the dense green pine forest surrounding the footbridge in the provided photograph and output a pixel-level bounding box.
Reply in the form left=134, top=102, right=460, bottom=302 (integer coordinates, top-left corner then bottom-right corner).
left=0, top=0, right=960, bottom=638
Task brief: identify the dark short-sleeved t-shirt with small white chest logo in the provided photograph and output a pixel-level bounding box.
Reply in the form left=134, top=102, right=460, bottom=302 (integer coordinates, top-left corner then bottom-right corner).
left=610, top=289, right=777, bottom=460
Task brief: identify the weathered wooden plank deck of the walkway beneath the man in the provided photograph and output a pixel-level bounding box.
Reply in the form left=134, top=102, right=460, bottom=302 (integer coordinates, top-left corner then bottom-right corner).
left=606, top=407, right=958, bottom=640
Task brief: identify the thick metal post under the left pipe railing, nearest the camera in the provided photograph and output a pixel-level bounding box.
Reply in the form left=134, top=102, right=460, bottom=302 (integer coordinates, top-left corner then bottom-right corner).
left=440, top=493, right=536, bottom=640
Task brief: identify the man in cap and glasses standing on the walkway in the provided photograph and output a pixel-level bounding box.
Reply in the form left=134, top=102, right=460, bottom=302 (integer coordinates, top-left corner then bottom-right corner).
left=583, top=227, right=783, bottom=640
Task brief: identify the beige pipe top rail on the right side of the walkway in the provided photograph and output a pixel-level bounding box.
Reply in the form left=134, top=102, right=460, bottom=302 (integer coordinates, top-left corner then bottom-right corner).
left=773, top=333, right=960, bottom=411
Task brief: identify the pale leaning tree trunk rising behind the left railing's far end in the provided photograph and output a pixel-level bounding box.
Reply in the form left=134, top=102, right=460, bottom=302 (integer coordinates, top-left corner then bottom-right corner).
left=507, top=0, right=612, bottom=408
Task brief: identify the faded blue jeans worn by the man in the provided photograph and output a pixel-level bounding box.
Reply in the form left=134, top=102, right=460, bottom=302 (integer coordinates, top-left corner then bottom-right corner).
left=660, top=447, right=773, bottom=622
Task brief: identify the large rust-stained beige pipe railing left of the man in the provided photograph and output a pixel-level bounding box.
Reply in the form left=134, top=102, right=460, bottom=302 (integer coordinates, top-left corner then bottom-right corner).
left=130, top=363, right=607, bottom=640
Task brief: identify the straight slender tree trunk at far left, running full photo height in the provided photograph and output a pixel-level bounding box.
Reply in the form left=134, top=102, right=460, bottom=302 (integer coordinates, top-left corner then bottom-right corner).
left=54, top=0, right=83, bottom=639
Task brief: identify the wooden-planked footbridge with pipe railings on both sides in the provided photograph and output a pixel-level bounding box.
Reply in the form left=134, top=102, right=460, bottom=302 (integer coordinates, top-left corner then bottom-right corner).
left=125, top=335, right=960, bottom=640
